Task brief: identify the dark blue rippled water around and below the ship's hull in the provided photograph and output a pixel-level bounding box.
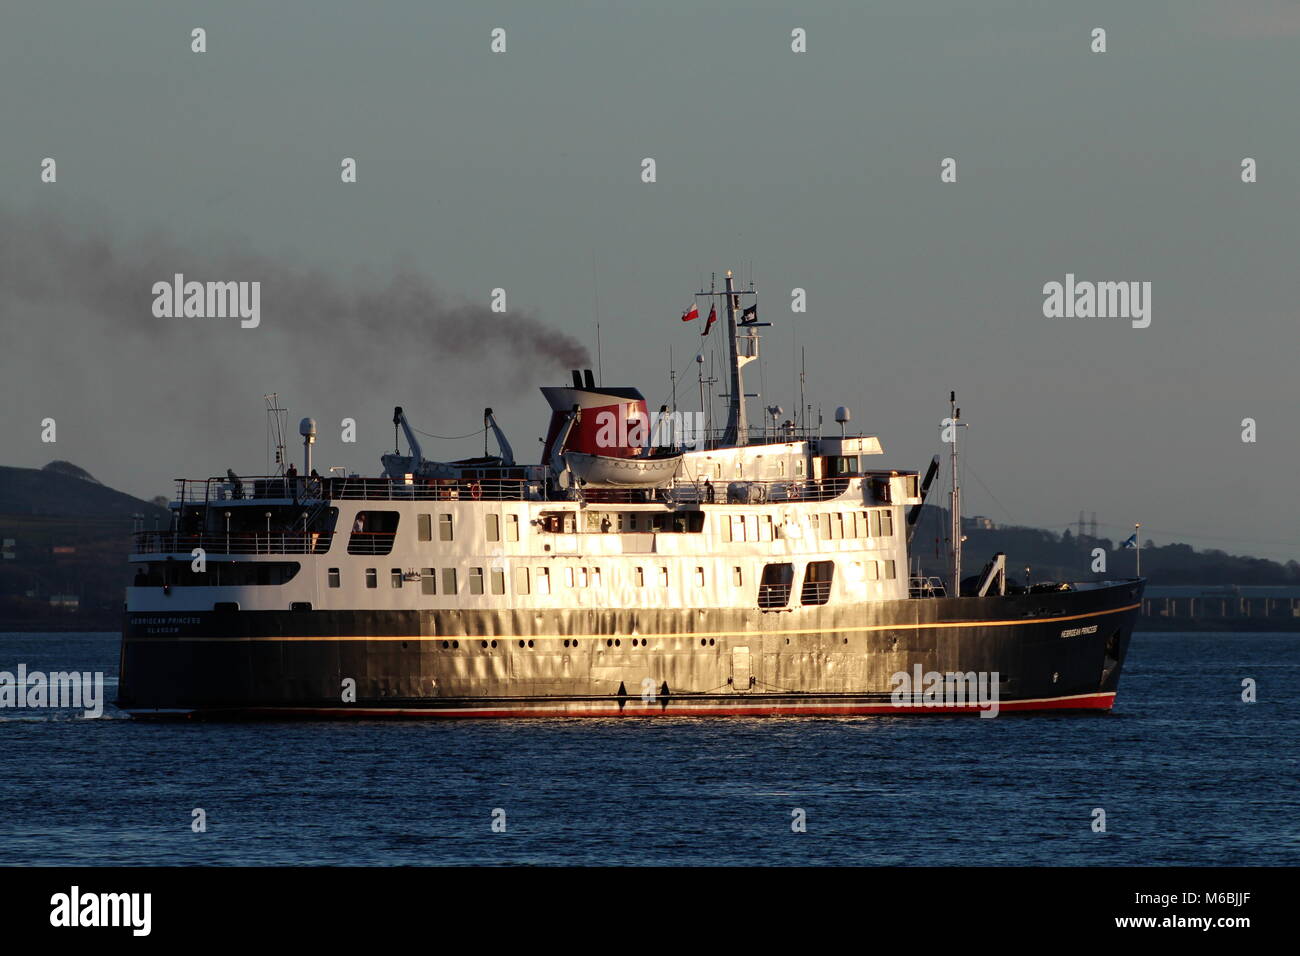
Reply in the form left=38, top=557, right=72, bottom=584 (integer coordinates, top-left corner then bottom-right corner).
left=0, top=633, right=1300, bottom=865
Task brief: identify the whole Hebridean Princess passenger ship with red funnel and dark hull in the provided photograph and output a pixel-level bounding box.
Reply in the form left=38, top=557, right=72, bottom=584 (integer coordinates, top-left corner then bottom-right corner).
left=117, top=272, right=1144, bottom=719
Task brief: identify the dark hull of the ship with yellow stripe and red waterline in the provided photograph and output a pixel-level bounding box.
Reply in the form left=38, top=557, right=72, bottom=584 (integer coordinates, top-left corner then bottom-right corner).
left=117, top=581, right=1143, bottom=718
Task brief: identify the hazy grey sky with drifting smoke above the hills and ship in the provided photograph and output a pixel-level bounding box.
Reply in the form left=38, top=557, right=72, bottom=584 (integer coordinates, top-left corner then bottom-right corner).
left=0, top=0, right=1300, bottom=558
